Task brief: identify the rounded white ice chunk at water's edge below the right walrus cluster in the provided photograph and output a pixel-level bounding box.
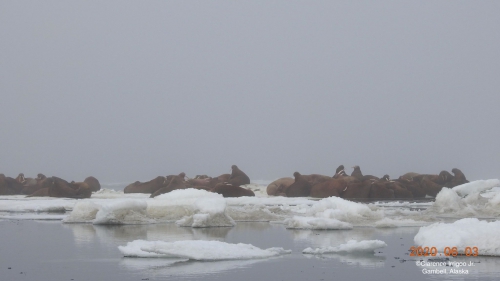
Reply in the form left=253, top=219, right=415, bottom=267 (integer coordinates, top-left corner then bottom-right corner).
left=306, top=197, right=384, bottom=224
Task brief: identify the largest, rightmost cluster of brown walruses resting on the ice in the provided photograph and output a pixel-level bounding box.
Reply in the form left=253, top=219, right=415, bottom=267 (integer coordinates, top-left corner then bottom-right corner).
left=267, top=165, right=469, bottom=201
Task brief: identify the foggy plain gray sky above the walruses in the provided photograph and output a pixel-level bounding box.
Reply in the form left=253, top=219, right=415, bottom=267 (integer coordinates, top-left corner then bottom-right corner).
left=0, top=0, right=500, bottom=182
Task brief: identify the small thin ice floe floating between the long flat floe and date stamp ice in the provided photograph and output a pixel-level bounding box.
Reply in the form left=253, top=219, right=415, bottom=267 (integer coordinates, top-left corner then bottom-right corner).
left=302, top=240, right=387, bottom=255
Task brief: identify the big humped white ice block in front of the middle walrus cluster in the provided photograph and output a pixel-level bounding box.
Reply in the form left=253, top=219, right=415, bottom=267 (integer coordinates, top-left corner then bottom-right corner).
left=64, top=189, right=235, bottom=227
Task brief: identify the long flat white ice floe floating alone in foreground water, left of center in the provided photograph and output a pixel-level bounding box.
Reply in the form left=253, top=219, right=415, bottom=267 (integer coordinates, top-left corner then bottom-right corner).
left=118, top=240, right=291, bottom=261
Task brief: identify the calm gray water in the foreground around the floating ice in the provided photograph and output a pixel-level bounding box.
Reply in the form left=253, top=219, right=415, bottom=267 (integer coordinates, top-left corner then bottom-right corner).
left=0, top=220, right=500, bottom=281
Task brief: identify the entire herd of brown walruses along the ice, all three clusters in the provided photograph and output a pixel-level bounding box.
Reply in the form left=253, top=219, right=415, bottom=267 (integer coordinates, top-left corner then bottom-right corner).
left=0, top=165, right=468, bottom=201
